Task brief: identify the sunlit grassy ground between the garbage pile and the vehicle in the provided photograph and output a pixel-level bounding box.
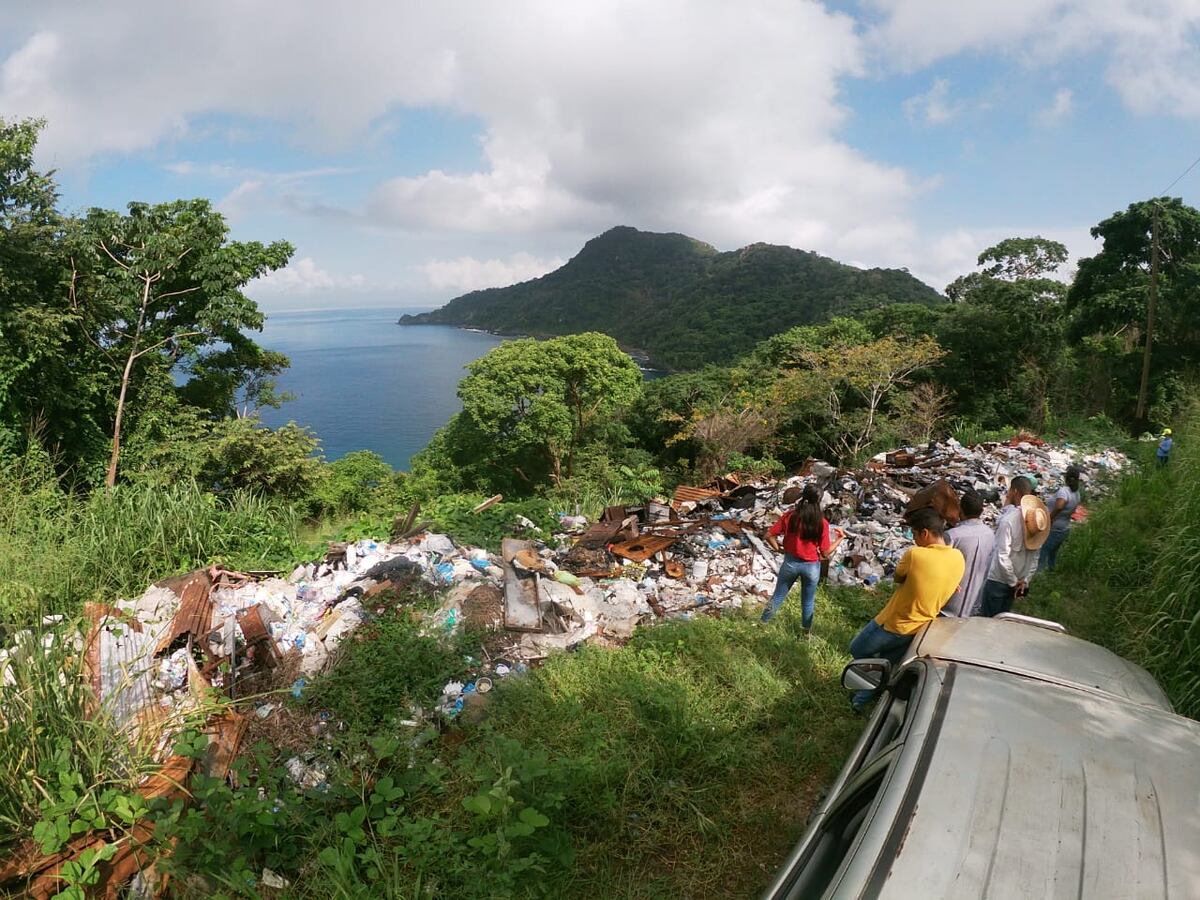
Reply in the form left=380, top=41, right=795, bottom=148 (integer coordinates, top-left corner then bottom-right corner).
left=472, top=595, right=872, bottom=896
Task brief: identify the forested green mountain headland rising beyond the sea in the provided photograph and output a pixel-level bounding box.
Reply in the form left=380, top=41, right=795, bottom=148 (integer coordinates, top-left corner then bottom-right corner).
left=400, top=227, right=944, bottom=370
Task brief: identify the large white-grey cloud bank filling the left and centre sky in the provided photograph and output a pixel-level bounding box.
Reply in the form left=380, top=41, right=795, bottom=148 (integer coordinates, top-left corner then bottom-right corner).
left=0, top=0, right=914, bottom=271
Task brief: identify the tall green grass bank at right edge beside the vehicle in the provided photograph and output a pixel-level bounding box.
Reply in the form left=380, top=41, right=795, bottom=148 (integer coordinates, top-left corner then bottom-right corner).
left=1030, top=412, right=1200, bottom=718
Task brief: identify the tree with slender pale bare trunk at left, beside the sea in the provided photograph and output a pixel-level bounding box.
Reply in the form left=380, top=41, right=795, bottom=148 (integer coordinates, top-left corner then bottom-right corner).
left=71, top=199, right=292, bottom=487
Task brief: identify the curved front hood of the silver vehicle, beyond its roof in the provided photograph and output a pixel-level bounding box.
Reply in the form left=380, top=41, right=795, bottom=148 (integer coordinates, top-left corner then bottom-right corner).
left=912, top=617, right=1171, bottom=709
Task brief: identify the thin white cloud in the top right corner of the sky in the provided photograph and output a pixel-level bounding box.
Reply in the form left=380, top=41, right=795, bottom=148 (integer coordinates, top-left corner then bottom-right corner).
left=868, top=0, right=1200, bottom=119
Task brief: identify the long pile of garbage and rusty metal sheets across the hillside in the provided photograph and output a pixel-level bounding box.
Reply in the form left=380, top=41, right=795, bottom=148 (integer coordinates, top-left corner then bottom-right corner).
left=9, top=436, right=1129, bottom=722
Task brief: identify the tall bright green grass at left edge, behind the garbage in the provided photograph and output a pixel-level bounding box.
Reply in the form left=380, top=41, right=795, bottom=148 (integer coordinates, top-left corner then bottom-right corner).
left=0, top=461, right=301, bottom=625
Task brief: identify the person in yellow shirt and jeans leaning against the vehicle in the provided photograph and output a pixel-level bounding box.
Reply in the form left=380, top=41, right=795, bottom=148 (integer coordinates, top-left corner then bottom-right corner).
left=850, top=508, right=966, bottom=710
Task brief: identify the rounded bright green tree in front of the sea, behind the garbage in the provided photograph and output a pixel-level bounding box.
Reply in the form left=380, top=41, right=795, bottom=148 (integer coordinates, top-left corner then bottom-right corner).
left=458, top=332, right=642, bottom=487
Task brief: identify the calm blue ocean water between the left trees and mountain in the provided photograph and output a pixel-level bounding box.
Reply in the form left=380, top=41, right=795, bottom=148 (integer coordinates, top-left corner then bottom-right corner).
left=259, top=310, right=500, bottom=469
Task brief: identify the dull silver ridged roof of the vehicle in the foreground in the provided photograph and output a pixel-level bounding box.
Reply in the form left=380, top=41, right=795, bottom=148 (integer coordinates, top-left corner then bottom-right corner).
left=876, top=664, right=1200, bottom=898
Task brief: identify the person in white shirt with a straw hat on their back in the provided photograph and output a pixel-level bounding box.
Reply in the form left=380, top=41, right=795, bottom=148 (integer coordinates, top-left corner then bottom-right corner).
left=979, top=475, right=1050, bottom=617
